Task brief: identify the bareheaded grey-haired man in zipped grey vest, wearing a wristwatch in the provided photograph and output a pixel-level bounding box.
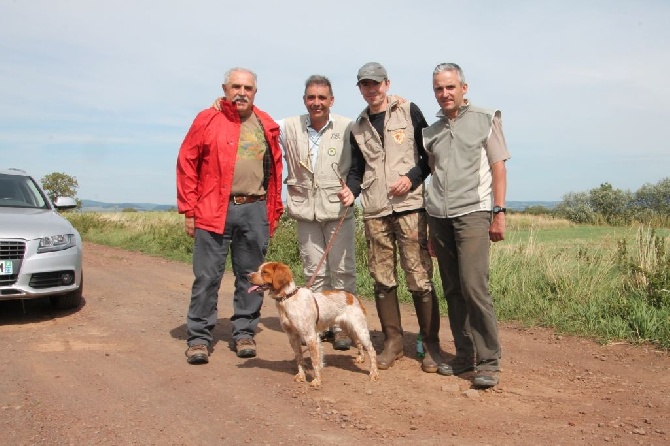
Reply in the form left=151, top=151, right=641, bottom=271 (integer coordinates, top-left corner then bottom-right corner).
left=423, top=63, right=510, bottom=388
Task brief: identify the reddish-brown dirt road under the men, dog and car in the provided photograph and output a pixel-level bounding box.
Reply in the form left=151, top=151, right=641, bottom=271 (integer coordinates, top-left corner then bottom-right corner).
left=0, top=244, right=670, bottom=445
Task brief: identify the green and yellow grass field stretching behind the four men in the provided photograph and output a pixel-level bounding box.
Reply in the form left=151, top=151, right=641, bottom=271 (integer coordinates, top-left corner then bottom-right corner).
left=67, top=212, right=670, bottom=349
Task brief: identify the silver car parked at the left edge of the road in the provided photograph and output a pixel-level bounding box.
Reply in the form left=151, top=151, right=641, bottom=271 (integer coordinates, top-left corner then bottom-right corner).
left=0, top=169, right=84, bottom=309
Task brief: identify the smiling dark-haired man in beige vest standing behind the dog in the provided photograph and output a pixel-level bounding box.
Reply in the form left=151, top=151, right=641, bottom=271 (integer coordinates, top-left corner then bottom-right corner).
left=278, top=75, right=356, bottom=350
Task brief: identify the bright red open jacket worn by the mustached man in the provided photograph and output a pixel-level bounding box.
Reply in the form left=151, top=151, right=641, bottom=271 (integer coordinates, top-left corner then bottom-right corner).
left=177, top=100, right=284, bottom=235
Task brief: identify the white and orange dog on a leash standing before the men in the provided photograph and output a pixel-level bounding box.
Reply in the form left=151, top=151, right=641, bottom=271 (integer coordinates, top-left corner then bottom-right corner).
left=249, top=262, right=379, bottom=387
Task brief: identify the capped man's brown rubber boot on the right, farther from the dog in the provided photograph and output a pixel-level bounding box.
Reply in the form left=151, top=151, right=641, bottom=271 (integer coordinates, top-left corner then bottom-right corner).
left=412, top=290, right=442, bottom=373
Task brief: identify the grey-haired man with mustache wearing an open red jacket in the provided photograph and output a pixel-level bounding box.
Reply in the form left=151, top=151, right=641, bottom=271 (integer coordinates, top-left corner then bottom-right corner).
left=177, top=68, right=284, bottom=364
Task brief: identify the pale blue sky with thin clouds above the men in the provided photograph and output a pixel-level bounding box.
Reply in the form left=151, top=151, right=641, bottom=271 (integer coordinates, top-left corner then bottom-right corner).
left=0, top=0, right=670, bottom=204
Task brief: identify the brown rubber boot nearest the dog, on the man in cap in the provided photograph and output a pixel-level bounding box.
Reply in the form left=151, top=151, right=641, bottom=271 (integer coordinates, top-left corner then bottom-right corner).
left=375, top=288, right=403, bottom=370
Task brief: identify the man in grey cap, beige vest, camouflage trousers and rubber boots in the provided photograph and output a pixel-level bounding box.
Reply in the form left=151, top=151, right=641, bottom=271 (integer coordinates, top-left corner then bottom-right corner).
left=339, top=62, right=441, bottom=373
